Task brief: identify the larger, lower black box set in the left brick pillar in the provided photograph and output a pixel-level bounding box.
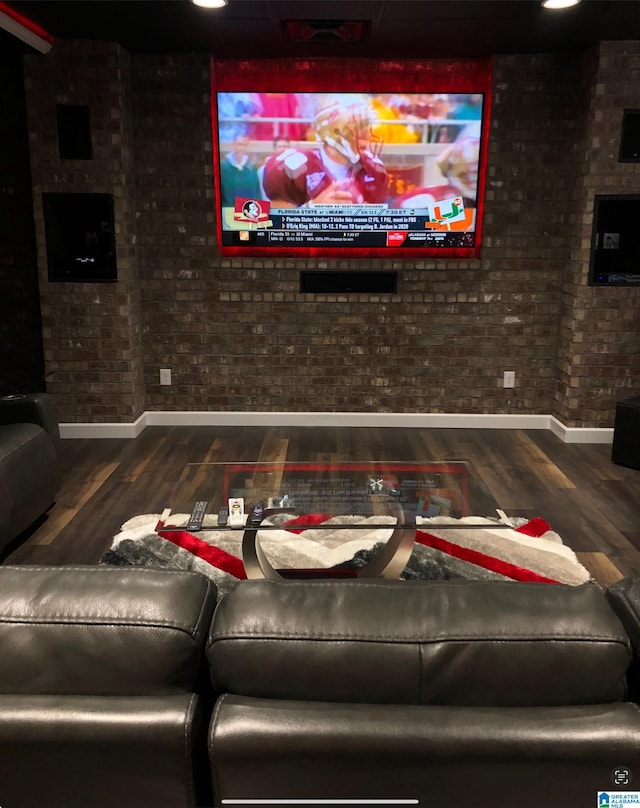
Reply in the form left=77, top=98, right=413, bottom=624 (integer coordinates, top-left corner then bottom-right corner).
left=42, top=193, right=118, bottom=283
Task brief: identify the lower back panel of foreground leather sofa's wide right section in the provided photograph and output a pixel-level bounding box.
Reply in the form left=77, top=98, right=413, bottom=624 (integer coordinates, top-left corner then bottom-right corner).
left=209, top=695, right=640, bottom=808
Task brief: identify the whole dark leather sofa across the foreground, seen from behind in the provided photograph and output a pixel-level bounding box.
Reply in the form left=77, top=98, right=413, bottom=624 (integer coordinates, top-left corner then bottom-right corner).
left=0, top=566, right=640, bottom=808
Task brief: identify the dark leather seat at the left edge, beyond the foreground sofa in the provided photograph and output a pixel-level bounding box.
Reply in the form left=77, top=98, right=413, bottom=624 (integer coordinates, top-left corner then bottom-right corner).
left=0, top=393, right=60, bottom=556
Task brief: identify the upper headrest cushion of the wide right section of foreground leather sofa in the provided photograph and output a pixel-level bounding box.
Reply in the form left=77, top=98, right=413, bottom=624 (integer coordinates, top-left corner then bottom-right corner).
left=208, top=580, right=631, bottom=706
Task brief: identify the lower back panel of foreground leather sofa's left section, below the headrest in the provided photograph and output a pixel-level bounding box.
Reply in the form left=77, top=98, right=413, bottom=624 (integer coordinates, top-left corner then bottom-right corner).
left=0, top=693, right=212, bottom=808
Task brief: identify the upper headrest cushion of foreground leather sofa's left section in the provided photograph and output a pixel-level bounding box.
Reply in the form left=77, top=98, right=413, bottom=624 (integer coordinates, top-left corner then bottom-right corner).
left=0, top=566, right=217, bottom=695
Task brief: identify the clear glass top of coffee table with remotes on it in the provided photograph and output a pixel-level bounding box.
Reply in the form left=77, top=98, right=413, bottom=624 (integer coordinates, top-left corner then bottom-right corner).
left=163, top=460, right=497, bottom=530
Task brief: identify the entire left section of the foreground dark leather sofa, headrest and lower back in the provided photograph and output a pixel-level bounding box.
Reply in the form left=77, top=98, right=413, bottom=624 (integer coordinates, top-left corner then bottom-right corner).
left=0, top=566, right=217, bottom=808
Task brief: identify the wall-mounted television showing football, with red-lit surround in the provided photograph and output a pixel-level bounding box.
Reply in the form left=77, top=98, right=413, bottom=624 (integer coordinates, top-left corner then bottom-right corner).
left=212, top=58, right=490, bottom=258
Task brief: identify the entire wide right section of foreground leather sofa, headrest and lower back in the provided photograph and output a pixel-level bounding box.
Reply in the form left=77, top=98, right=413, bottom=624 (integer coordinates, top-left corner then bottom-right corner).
left=208, top=580, right=640, bottom=808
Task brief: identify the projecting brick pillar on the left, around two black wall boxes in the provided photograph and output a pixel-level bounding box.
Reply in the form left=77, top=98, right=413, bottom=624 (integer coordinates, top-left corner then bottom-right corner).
left=25, top=42, right=145, bottom=421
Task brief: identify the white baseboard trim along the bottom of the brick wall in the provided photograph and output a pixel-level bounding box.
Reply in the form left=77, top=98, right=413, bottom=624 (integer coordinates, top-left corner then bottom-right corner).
left=60, top=410, right=613, bottom=443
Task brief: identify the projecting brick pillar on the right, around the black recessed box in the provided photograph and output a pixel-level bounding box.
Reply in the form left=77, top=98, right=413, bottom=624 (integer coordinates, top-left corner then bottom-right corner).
left=556, top=42, right=640, bottom=426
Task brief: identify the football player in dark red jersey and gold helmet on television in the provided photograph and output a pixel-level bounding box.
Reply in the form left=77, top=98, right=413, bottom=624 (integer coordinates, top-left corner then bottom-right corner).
left=263, top=99, right=389, bottom=207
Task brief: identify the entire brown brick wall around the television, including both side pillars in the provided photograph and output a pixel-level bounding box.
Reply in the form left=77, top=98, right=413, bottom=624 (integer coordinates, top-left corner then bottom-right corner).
left=18, top=42, right=640, bottom=426
